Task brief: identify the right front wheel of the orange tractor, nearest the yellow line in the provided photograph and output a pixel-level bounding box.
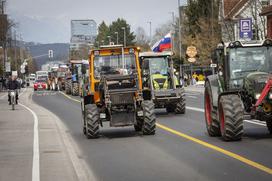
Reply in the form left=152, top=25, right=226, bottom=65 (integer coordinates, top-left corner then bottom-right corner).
left=142, top=101, right=156, bottom=135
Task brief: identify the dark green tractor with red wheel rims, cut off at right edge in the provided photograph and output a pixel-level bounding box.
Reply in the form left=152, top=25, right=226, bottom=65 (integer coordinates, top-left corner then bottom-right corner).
left=204, top=39, right=272, bottom=141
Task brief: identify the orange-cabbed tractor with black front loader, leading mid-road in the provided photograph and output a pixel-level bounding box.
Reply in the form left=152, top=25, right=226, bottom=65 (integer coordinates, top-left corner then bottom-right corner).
left=81, top=46, right=156, bottom=138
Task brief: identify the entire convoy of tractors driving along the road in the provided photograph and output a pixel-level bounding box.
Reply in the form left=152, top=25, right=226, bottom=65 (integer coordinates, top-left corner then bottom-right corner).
left=33, top=39, right=272, bottom=141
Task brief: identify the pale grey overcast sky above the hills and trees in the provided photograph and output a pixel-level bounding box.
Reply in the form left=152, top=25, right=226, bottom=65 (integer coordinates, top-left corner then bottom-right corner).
left=7, top=0, right=186, bottom=43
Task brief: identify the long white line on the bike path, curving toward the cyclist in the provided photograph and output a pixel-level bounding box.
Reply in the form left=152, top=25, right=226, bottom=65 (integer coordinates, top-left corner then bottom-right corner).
left=19, top=89, right=40, bottom=181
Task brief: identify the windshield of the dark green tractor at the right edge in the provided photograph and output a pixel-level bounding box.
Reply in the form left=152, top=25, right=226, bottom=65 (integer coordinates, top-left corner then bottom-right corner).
left=229, top=46, right=272, bottom=87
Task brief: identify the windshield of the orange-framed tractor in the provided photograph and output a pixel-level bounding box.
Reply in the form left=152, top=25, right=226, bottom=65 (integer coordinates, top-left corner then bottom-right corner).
left=94, top=54, right=136, bottom=79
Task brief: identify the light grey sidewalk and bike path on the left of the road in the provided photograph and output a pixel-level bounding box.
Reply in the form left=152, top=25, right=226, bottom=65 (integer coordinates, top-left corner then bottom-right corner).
left=0, top=89, right=86, bottom=181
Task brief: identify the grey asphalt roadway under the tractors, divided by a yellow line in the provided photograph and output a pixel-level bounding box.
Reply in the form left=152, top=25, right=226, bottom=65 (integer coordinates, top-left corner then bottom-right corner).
left=33, top=93, right=272, bottom=181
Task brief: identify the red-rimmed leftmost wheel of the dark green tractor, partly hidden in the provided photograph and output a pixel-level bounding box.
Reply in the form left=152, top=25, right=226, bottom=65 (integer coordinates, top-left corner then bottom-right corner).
left=204, top=82, right=221, bottom=136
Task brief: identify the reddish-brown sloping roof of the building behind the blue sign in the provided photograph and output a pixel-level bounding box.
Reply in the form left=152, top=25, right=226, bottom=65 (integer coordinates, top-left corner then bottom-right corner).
left=223, top=0, right=249, bottom=19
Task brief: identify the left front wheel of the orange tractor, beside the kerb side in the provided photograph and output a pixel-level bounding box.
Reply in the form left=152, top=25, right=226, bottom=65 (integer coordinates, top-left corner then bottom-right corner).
left=83, top=104, right=99, bottom=139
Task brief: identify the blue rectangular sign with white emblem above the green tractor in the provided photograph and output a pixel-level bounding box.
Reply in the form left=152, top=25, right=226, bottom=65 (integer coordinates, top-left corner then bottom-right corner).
left=239, top=18, right=253, bottom=39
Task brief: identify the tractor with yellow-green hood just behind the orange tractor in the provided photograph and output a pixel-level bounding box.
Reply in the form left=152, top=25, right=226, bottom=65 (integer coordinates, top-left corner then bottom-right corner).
left=140, top=52, right=185, bottom=114
